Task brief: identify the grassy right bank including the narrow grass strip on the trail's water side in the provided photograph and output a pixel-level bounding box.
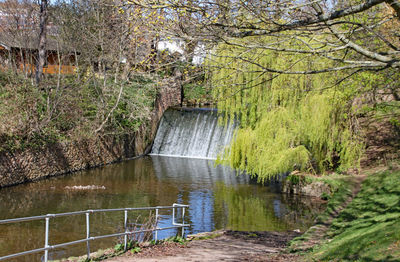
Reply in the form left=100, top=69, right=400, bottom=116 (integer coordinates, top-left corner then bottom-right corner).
left=290, top=170, right=400, bottom=261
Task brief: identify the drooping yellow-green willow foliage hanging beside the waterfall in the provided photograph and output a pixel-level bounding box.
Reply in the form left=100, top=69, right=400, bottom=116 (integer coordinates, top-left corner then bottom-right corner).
left=207, top=37, right=363, bottom=181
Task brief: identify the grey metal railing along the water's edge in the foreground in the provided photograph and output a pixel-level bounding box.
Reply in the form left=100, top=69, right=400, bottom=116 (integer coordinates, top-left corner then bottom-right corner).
left=0, top=204, right=190, bottom=262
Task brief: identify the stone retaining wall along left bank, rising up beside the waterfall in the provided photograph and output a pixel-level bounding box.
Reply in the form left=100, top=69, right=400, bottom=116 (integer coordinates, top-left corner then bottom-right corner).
left=0, top=81, right=180, bottom=188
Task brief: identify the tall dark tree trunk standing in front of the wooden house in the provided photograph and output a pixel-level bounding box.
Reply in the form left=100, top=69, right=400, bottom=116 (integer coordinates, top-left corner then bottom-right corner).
left=35, top=0, right=48, bottom=85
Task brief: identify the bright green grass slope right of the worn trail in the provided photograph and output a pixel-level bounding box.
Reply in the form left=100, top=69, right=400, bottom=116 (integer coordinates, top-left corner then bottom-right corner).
left=310, top=171, right=400, bottom=261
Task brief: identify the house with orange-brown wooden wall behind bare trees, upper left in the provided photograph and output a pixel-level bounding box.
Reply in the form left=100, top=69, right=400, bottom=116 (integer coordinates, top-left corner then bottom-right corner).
left=0, top=1, right=76, bottom=74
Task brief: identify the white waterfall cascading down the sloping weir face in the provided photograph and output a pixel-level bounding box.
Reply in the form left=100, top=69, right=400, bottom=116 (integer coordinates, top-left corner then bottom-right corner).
left=151, top=109, right=235, bottom=159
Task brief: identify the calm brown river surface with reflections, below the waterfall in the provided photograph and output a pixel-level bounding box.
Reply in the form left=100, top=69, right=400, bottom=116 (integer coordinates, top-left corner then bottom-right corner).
left=0, top=156, right=321, bottom=261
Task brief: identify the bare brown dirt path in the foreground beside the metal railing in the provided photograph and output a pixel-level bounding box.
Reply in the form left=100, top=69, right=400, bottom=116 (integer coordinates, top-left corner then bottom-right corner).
left=106, top=231, right=299, bottom=262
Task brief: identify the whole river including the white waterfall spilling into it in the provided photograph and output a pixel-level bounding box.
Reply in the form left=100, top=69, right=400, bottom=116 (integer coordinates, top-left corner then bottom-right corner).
left=0, top=109, right=323, bottom=262
